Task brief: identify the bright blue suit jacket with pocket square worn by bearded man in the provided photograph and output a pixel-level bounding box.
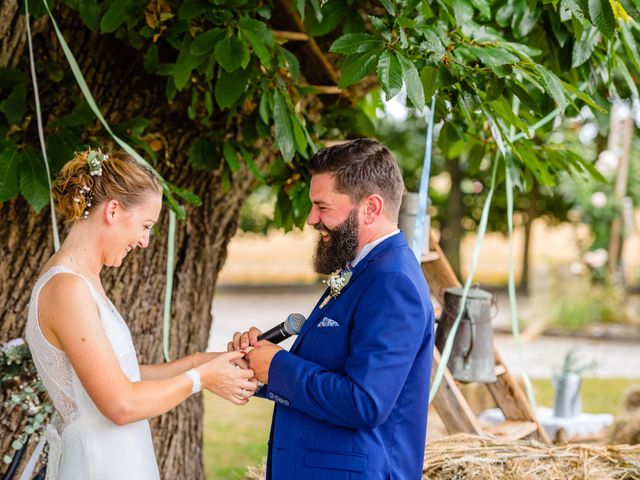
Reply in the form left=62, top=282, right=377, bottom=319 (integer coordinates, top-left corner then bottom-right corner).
left=262, top=233, right=433, bottom=480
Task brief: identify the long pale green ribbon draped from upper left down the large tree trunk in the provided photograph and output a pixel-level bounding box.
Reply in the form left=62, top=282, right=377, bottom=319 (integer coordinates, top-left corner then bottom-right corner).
left=42, top=0, right=176, bottom=361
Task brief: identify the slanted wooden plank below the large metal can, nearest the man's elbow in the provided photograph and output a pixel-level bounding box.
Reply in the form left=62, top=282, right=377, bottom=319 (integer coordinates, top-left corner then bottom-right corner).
left=431, top=348, right=482, bottom=435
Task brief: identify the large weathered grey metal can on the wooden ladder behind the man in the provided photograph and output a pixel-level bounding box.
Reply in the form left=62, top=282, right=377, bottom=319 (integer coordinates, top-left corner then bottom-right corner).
left=435, top=287, right=496, bottom=383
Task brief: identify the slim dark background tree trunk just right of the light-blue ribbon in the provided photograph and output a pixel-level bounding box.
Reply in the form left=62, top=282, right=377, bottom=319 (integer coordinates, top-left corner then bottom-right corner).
left=440, top=158, right=464, bottom=278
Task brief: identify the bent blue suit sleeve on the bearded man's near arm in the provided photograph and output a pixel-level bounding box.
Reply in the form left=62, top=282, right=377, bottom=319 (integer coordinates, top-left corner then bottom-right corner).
left=268, top=273, right=433, bottom=429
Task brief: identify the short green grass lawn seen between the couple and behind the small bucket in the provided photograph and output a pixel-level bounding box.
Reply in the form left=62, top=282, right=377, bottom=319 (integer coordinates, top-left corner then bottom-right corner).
left=204, top=378, right=640, bottom=480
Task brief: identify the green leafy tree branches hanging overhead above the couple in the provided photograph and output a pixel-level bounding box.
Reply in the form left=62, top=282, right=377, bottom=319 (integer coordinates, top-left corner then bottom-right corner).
left=0, top=0, right=640, bottom=230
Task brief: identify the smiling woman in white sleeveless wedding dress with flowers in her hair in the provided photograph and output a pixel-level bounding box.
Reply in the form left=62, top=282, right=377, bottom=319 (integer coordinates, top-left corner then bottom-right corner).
left=26, top=150, right=256, bottom=480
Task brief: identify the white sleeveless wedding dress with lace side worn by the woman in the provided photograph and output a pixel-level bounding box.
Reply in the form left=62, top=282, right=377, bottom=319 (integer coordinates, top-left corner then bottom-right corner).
left=26, top=265, right=160, bottom=480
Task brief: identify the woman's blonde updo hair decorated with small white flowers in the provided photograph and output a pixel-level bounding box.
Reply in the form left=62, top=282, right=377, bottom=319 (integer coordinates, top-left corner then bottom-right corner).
left=51, top=149, right=162, bottom=222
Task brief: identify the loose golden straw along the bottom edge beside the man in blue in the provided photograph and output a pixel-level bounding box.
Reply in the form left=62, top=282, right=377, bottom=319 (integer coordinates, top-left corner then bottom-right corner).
left=245, top=434, right=640, bottom=480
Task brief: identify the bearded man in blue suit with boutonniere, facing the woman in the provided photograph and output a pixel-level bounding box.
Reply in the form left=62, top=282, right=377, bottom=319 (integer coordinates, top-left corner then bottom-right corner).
left=229, top=139, right=433, bottom=480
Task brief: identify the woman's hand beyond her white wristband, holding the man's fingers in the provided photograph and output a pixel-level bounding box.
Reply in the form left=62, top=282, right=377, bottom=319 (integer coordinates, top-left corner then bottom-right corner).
left=198, top=351, right=257, bottom=405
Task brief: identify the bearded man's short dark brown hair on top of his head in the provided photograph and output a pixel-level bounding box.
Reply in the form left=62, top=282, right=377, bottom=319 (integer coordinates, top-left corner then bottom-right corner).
left=309, top=138, right=404, bottom=221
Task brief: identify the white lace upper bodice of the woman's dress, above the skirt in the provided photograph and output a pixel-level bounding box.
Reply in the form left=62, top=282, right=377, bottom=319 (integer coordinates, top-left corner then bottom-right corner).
left=26, top=265, right=140, bottom=426
